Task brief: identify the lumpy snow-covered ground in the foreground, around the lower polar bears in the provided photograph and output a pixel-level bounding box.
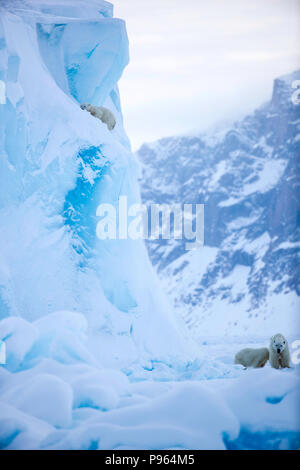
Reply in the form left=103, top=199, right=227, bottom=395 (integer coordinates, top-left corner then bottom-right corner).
left=0, top=312, right=300, bottom=450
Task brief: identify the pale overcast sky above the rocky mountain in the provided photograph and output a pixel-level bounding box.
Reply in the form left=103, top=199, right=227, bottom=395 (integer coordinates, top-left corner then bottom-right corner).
left=111, top=0, right=300, bottom=149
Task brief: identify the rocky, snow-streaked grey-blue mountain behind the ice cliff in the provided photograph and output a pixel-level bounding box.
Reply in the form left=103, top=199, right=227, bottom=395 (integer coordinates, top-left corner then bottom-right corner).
left=138, top=71, right=300, bottom=335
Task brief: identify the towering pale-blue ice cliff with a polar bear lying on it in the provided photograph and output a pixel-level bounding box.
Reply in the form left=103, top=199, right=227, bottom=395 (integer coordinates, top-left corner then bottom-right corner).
left=0, top=0, right=192, bottom=366
